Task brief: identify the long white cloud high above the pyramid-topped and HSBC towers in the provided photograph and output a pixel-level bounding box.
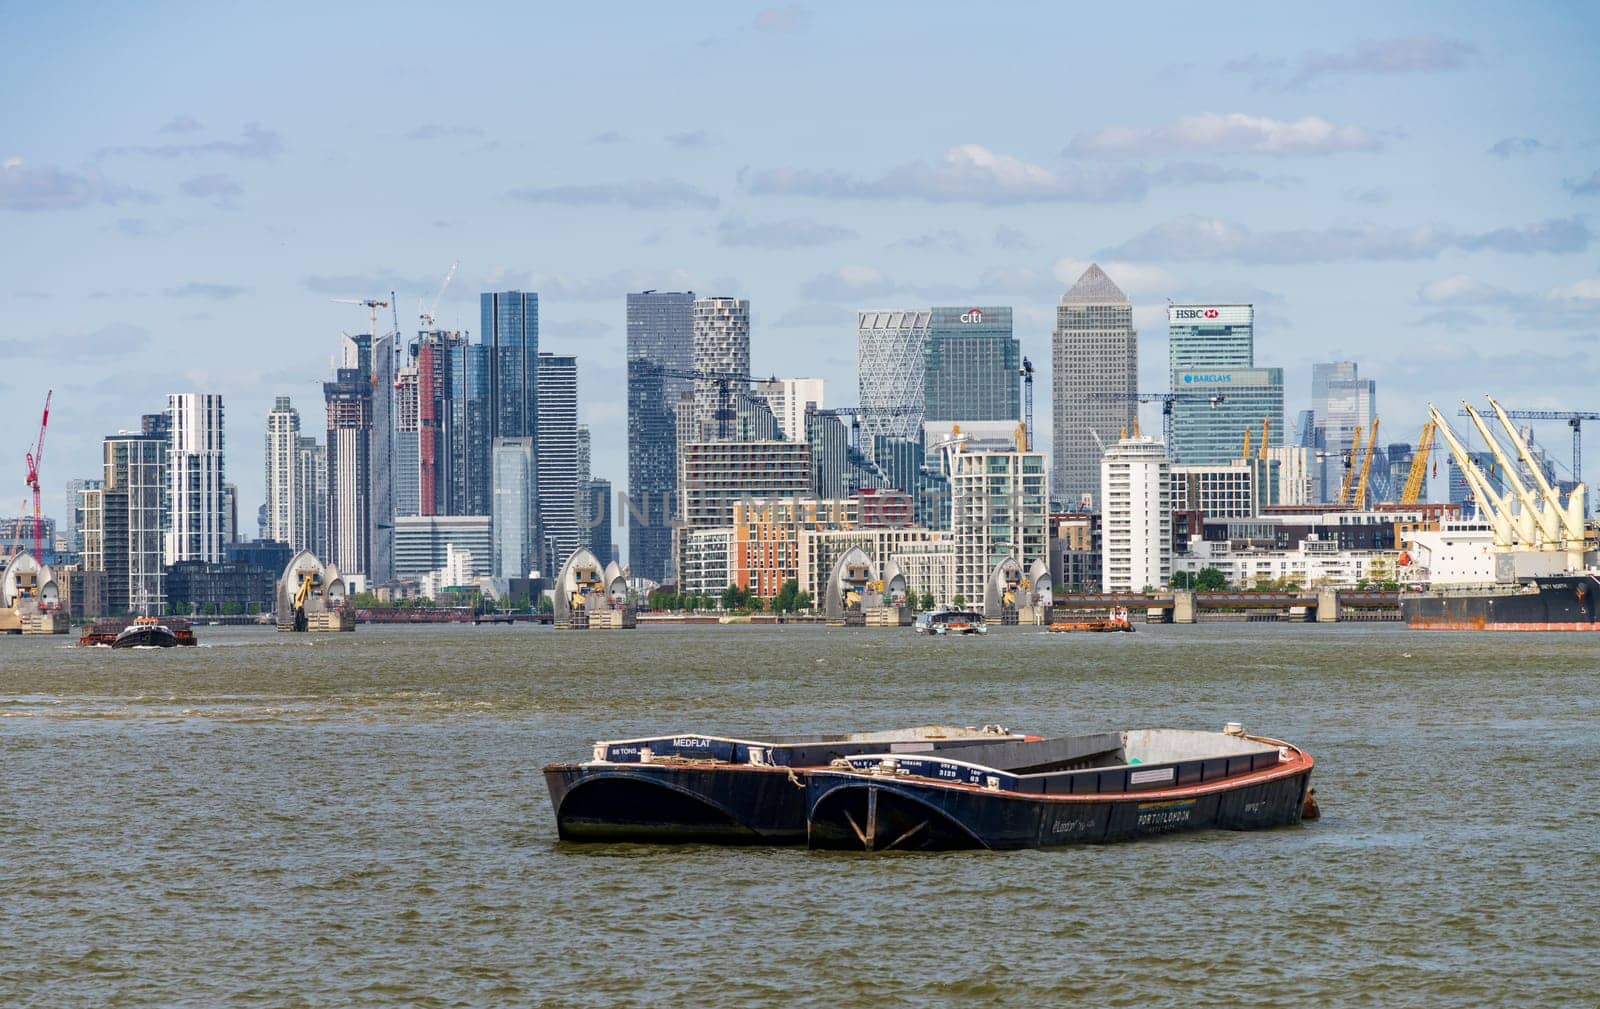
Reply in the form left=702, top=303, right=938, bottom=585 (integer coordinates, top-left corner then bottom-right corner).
left=1064, top=112, right=1382, bottom=158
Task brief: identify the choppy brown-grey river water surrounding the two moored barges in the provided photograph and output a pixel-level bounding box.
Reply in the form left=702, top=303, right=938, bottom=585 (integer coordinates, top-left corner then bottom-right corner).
left=0, top=625, right=1600, bottom=1007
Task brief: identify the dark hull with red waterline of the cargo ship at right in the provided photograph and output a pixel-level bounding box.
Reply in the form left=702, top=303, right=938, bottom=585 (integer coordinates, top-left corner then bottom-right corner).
left=1400, top=574, right=1600, bottom=632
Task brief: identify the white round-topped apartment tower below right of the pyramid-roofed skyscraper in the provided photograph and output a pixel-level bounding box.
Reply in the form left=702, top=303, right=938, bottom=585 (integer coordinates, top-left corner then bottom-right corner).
left=1101, top=435, right=1173, bottom=592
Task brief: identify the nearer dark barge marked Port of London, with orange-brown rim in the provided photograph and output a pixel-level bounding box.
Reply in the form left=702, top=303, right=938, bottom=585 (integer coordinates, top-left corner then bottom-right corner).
left=806, top=723, right=1314, bottom=851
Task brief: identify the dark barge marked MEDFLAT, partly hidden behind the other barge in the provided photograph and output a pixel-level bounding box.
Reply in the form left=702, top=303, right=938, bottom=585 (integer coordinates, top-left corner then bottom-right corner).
left=544, top=726, right=1027, bottom=844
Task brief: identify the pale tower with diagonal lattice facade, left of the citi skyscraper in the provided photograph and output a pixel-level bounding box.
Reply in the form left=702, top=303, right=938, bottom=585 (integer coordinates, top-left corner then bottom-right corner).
left=856, top=309, right=933, bottom=450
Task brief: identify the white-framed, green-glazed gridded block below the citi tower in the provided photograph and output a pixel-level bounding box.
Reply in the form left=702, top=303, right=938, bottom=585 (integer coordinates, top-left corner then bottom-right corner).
left=950, top=451, right=1050, bottom=604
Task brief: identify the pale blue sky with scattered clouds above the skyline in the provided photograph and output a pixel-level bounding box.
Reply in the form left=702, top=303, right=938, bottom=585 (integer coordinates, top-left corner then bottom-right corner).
left=0, top=0, right=1600, bottom=544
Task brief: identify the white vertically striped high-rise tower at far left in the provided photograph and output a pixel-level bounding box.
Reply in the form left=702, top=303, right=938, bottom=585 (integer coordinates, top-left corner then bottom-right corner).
left=166, top=392, right=226, bottom=564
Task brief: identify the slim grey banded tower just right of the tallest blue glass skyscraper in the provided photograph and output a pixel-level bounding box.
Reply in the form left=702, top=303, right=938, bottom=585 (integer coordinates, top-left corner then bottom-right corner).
left=534, top=353, right=579, bottom=577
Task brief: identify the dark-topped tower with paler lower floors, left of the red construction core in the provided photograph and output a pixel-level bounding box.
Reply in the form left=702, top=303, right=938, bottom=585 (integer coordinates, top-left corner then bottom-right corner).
left=318, top=368, right=373, bottom=577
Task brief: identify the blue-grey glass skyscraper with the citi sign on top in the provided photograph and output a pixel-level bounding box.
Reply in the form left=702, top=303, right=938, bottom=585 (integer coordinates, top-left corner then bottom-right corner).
left=923, top=307, right=1022, bottom=422
